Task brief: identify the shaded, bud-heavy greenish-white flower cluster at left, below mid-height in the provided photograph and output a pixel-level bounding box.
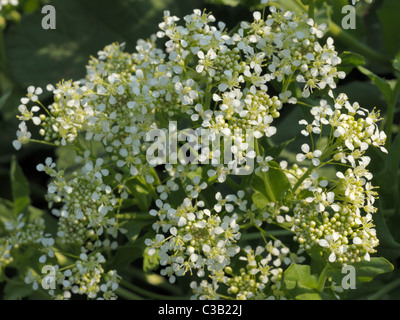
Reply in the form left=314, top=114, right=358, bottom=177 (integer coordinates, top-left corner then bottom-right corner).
left=37, top=156, right=119, bottom=246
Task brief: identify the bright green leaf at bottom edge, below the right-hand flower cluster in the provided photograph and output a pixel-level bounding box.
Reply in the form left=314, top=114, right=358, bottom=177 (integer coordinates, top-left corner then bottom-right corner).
left=283, top=264, right=321, bottom=299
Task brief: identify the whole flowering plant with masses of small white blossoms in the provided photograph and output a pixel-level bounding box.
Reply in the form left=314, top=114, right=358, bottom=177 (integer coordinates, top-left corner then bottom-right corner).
left=0, top=1, right=398, bottom=299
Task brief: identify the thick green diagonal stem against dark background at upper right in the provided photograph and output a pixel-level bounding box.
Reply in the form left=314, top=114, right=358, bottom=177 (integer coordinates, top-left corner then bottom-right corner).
left=329, top=21, right=392, bottom=68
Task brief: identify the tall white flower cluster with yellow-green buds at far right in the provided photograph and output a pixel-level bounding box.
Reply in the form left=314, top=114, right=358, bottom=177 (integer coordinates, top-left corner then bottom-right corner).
left=293, top=93, right=387, bottom=263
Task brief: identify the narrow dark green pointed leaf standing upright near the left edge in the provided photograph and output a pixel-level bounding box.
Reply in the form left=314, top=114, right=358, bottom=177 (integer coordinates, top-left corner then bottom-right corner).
left=10, top=156, right=31, bottom=216
